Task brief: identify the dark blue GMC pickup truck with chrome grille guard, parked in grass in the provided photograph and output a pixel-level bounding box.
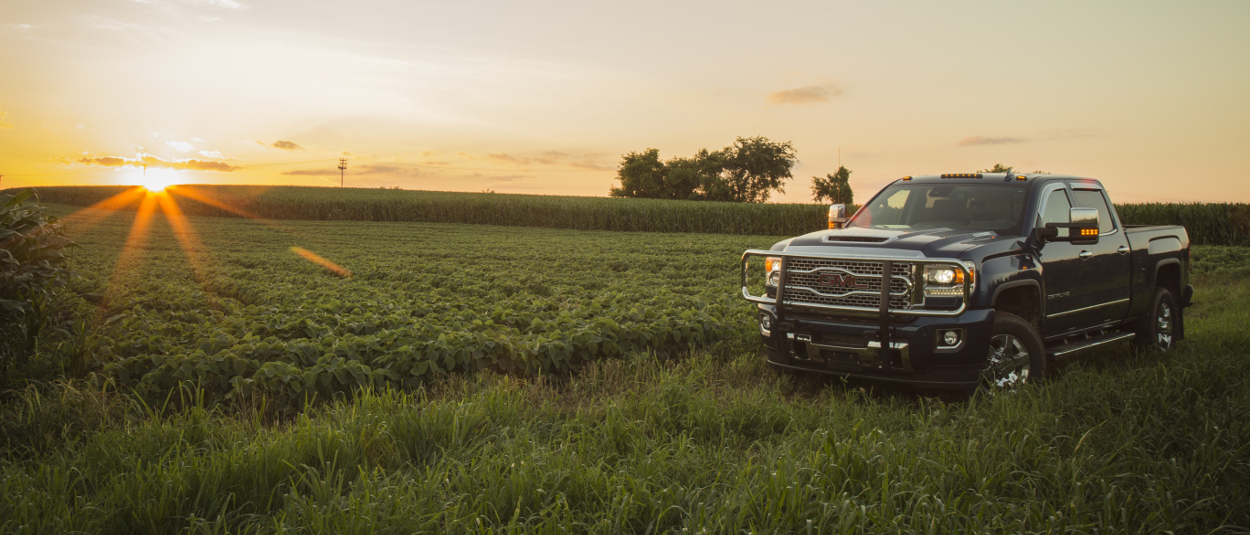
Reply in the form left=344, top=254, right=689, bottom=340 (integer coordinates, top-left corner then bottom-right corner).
left=743, top=171, right=1194, bottom=389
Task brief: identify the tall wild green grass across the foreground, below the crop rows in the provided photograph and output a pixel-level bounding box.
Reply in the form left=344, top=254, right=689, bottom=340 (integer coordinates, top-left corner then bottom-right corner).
left=0, top=265, right=1250, bottom=534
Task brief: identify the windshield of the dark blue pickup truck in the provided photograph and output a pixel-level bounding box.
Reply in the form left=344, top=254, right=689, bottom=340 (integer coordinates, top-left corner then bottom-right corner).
left=846, top=184, right=1028, bottom=235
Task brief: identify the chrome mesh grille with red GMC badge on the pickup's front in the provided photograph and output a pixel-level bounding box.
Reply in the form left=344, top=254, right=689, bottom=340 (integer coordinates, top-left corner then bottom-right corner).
left=784, top=258, right=913, bottom=309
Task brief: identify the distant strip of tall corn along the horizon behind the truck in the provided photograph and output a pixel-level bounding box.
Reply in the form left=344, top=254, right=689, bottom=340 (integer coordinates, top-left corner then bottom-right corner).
left=12, top=186, right=1250, bottom=246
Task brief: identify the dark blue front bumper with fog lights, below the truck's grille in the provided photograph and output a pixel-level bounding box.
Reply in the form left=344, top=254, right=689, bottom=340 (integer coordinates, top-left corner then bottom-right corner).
left=758, top=304, right=994, bottom=389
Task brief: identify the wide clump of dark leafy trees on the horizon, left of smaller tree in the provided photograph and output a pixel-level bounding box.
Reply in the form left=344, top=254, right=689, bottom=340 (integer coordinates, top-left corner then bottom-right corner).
left=610, top=136, right=799, bottom=203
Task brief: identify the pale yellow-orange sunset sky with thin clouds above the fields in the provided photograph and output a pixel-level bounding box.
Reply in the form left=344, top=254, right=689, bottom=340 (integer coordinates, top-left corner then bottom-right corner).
left=0, top=0, right=1250, bottom=203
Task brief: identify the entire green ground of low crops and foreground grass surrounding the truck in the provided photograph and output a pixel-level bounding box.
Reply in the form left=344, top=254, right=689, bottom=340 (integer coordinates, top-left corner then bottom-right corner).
left=0, top=200, right=1250, bottom=534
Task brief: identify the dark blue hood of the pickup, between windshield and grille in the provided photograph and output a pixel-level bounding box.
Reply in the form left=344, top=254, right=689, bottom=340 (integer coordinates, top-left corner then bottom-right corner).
left=778, top=228, right=1008, bottom=258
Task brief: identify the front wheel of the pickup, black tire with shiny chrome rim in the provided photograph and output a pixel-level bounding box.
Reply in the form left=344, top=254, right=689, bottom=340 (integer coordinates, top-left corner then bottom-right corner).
left=983, top=313, right=1046, bottom=389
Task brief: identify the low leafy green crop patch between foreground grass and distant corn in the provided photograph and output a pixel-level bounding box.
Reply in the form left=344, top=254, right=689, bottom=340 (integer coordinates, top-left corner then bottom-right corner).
left=58, top=211, right=774, bottom=404
